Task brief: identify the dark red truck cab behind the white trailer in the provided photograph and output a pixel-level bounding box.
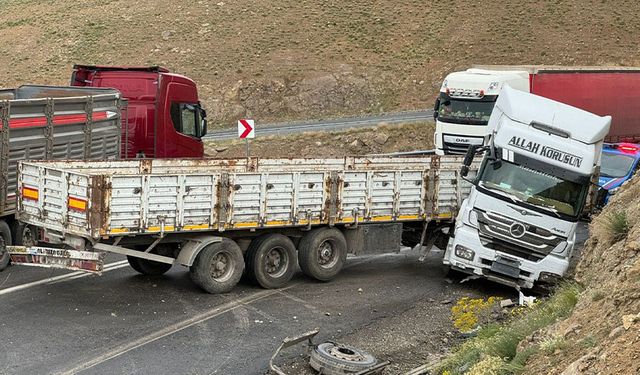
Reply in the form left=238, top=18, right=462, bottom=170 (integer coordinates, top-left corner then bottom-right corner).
left=71, top=65, right=207, bottom=158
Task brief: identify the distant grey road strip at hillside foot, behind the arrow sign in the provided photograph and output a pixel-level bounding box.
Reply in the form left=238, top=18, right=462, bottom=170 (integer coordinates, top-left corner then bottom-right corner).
left=204, top=110, right=433, bottom=140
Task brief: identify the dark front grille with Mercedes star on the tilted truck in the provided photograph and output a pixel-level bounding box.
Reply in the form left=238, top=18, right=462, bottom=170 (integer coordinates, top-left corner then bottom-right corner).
left=475, top=209, right=566, bottom=262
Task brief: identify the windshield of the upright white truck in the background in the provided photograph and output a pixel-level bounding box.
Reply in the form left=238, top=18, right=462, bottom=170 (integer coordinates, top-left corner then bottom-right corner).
left=438, top=93, right=495, bottom=125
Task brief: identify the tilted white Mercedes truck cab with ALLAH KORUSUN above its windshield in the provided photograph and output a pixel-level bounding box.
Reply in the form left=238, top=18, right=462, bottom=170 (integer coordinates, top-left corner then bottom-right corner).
left=444, top=86, right=611, bottom=288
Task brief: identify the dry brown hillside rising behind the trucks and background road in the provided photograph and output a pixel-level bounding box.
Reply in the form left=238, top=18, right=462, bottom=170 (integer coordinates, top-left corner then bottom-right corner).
left=0, top=0, right=640, bottom=126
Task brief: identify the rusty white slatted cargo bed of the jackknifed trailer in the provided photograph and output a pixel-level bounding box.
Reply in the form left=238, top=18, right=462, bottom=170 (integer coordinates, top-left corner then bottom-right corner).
left=19, top=156, right=478, bottom=239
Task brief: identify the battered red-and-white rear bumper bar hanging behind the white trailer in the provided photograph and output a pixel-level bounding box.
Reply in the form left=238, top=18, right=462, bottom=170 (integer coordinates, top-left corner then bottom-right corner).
left=7, top=246, right=105, bottom=274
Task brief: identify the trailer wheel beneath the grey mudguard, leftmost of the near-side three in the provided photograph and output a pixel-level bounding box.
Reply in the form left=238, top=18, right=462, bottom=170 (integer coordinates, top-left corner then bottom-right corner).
left=189, top=238, right=244, bottom=294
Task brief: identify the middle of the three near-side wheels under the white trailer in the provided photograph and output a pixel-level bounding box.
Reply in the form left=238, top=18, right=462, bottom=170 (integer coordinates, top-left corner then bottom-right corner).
left=245, top=233, right=296, bottom=289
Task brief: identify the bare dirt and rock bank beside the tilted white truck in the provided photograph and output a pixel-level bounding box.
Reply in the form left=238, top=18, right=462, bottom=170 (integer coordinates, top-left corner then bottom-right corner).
left=526, top=176, right=640, bottom=375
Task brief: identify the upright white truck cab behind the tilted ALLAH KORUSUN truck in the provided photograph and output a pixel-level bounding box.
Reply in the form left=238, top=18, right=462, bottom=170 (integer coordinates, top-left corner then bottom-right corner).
left=434, top=69, right=529, bottom=155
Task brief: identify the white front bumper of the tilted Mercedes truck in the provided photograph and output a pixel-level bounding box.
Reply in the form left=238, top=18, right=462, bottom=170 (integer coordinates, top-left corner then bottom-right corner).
left=443, top=225, right=569, bottom=288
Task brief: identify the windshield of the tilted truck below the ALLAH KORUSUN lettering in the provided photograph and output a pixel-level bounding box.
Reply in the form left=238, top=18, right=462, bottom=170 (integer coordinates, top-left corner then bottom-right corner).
left=478, top=160, right=588, bottom=218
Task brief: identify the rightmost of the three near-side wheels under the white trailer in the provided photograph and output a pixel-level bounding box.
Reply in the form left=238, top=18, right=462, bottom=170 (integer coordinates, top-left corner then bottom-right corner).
left=298, top=228, right=347, bottom=281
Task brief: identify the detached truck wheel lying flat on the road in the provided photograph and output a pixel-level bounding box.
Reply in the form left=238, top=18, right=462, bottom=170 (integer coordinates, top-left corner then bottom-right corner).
left=309, top=342, right=377, bottom=375
